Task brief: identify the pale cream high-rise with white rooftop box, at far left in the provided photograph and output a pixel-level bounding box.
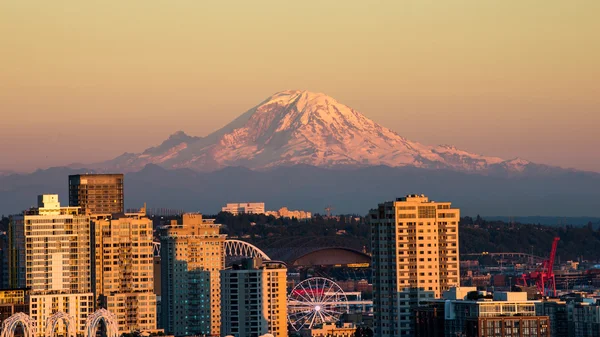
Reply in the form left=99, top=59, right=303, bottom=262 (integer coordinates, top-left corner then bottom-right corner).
left=9, top=195, right=94, bottom=336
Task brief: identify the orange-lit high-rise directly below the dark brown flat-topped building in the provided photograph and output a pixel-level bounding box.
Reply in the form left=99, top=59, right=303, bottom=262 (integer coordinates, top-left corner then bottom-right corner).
left=92, top=208, right=156, bottom=334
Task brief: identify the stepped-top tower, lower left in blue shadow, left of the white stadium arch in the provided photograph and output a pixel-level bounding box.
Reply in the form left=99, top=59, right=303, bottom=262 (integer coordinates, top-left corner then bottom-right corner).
left=161, top=214, right=226, bottom=336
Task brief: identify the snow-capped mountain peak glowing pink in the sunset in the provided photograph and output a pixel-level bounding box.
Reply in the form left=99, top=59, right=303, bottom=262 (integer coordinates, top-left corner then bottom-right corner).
left=99, top=90, right=531, bottom=173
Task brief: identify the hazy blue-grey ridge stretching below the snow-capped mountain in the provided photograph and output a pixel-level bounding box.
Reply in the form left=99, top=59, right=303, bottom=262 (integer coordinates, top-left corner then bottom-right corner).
left=0, top=164, right=600, bottom=217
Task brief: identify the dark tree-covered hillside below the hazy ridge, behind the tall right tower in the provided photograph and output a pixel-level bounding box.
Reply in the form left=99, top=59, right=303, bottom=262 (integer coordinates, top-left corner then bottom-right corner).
left=212, top=213, right=600, bottom=261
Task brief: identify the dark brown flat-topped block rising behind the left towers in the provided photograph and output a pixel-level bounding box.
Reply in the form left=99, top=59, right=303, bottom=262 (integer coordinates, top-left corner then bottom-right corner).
left=69, top=174, right=125, bottom=214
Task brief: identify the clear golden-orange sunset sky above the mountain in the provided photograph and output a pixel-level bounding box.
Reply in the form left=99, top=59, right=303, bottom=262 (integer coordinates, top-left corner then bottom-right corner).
left=0, top=0, right=600, bottom=172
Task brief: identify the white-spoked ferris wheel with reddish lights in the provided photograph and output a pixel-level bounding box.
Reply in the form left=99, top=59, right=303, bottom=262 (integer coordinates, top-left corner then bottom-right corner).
left=288, top=277, right=349, bottom=331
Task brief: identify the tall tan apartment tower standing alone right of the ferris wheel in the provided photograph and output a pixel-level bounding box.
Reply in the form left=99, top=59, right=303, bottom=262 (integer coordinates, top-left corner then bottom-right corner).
left=369, top=195, right=460, bottom=337
